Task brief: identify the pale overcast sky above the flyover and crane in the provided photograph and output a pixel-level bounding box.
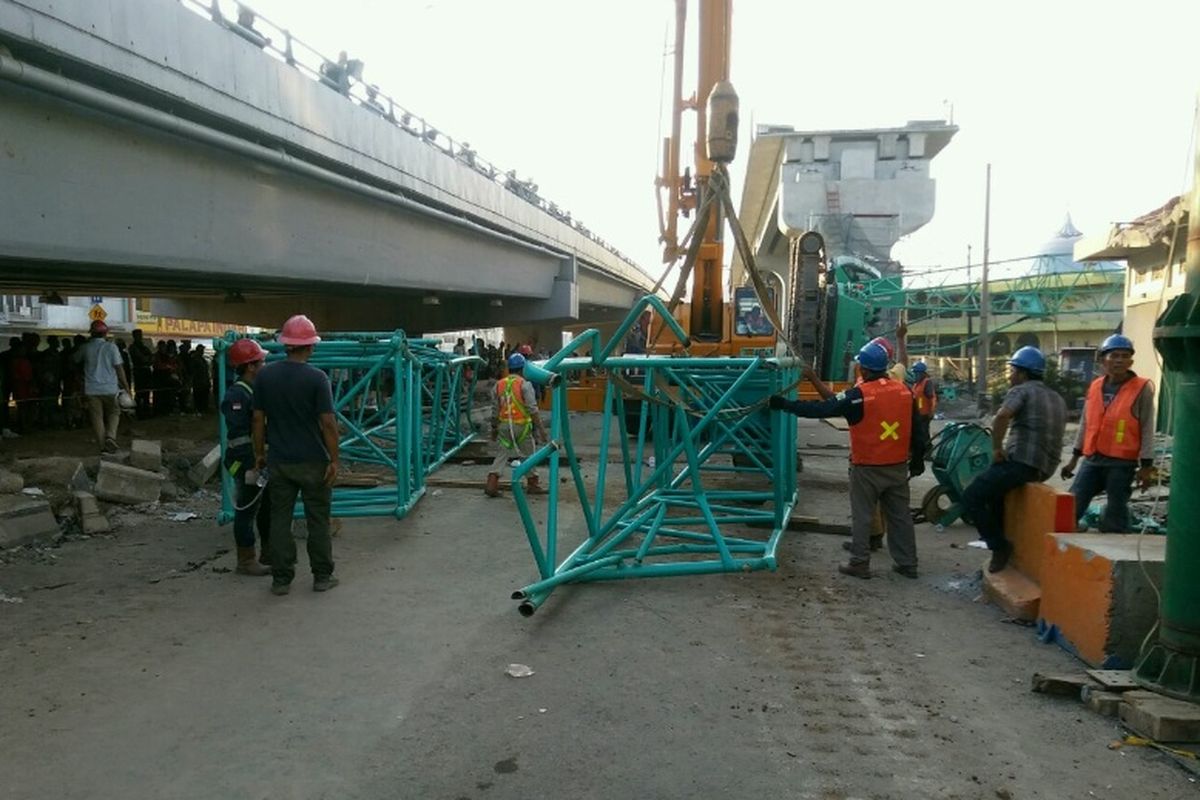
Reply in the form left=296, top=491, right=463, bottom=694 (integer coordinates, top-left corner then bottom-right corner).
left=229, top=0, right=1200, bottom=280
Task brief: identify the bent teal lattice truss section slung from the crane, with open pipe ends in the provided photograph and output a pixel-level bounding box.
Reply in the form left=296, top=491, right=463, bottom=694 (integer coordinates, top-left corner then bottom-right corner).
left=512, top=296, right=800, bottom=615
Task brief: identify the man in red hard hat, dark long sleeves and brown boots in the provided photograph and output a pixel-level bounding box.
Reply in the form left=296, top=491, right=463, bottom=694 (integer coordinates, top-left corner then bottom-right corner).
left=221, top=339, right=271, bottom=576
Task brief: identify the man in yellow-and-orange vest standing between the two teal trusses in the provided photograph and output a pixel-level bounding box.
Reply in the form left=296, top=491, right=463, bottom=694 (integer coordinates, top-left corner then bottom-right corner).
left=484, top=353, right=546, bottom=498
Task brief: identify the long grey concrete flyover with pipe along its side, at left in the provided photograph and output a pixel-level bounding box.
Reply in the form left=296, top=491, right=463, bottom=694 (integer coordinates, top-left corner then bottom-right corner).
left=0, top=0, right=653, bottom=331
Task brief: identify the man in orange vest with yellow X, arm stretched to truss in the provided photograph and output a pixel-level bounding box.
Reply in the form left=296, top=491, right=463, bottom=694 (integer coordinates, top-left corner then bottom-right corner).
left=768, top=342, right=925, bottom=578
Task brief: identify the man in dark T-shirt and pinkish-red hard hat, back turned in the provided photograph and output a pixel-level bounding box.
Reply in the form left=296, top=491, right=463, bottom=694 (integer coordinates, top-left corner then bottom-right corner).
left=253, top=314, right=338, bottom=595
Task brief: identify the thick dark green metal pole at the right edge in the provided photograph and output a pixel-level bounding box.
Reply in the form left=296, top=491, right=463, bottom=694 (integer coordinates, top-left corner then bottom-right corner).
left=1134, top=90, right=1200, bottom=702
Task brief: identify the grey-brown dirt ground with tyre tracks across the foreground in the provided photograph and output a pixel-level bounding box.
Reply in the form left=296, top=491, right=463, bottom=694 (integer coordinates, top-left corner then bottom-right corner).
left=0, top=419, right=1196, bottom=800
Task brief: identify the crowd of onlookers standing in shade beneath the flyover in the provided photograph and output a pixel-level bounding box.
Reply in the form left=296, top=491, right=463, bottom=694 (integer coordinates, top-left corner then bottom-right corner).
left=0, top=330, right=216, bottom=435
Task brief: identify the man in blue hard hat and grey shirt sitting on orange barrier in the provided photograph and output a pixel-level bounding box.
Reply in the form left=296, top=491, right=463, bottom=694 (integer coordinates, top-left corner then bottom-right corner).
left=962, top=347, right=1067, bottom=572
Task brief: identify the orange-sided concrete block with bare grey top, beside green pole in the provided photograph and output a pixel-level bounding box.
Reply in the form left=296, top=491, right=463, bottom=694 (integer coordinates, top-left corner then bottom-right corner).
left=1038, top=534, right=1166, bottom=669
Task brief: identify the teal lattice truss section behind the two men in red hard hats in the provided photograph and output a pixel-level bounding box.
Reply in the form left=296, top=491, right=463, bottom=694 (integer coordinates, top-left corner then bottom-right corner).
left=215, top=331, right=481, bottom=524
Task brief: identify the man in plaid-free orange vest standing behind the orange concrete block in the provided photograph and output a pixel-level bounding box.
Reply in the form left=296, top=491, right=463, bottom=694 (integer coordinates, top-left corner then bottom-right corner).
left=1062, top=333, right=1154, bottom=534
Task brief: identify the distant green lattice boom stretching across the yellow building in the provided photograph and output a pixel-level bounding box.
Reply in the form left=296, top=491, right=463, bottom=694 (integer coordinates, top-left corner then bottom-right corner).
left=842, top=267, right=1124, bottom=321
